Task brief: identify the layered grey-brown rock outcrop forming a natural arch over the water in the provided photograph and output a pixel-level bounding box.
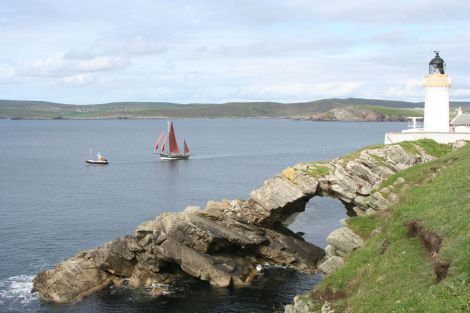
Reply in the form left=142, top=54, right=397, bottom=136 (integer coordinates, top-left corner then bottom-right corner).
left=33, top=140, right=444, bottom=303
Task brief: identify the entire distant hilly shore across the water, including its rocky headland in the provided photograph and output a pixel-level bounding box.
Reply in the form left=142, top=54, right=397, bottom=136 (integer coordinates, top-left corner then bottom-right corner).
left=0, top=98, right=470, bottom=120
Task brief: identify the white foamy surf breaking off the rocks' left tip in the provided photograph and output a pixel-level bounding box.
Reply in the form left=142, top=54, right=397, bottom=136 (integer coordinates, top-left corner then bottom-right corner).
left=0, top=275, right=39, bottom=312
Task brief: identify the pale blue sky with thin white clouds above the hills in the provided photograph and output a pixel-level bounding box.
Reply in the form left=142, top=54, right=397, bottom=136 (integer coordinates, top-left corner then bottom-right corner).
left=0, top=0, right=470, bottom=104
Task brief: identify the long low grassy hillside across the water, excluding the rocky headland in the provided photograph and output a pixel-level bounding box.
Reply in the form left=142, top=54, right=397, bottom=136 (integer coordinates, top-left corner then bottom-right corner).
left=0, top=99, right=422, bottom=118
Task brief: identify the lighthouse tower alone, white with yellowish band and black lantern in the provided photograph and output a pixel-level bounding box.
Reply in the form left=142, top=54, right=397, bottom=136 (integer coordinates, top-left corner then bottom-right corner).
left=424, top=51, right=451, bottom=132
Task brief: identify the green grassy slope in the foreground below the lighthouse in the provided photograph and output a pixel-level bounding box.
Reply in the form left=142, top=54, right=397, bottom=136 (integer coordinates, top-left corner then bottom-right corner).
left=309, top=144, right=470, bottom=312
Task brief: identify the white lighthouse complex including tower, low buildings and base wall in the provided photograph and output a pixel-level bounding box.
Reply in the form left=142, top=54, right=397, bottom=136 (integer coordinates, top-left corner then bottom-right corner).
left=385, top=51, right=470, bottom=144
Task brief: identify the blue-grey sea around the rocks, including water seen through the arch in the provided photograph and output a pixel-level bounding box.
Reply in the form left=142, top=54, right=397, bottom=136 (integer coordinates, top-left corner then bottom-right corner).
left=0, top=119, right=403, bottom=312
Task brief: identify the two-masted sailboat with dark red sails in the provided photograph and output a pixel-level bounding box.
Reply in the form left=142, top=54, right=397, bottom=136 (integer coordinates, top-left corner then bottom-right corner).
left=153, top=121, right=191, bottom=160
